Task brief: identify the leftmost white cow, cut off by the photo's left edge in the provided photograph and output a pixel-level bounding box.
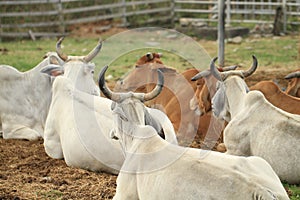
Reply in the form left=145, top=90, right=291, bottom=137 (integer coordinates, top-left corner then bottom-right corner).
left=0, top=52, right=63, bottom=140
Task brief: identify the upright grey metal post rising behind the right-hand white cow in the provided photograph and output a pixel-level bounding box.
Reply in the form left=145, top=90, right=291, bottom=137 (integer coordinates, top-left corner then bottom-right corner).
left=218, top=0, right=225, bottom=67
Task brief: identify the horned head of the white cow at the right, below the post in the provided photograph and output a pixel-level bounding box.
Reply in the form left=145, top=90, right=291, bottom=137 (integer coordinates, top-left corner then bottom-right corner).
left=210, top=56, right=258, bottom=122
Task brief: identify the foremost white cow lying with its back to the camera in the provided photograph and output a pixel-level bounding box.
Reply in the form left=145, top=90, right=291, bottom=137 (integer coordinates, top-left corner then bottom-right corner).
left=100, top=66, right=289, bottom=200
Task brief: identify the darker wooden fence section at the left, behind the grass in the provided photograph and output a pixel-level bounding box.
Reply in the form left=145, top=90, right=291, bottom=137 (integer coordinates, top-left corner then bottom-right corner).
left=0, top=0, right=173, bottom=38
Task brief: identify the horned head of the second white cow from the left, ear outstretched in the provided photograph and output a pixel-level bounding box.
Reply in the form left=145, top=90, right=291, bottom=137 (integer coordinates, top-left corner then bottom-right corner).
left=42, top=38, right=102, bottom=96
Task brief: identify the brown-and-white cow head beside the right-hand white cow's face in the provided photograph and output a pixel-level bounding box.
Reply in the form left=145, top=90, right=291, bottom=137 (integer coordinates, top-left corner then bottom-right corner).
left=190, top=66, right=237, bottom=116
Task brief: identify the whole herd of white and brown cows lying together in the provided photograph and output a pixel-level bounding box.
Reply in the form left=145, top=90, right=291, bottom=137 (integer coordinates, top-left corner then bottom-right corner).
left=0, top=38, right=300, bottom=200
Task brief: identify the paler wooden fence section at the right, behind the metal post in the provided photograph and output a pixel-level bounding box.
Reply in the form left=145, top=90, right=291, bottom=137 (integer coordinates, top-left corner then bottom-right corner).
left=174, top=0, right=300, bottom=31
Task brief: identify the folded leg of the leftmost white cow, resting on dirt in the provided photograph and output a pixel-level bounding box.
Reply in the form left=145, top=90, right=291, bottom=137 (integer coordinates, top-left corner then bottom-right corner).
left=2, top=122, right=41, bottom=140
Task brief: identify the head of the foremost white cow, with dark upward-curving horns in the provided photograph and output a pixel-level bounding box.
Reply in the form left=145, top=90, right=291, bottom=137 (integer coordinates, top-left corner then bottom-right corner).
left=99, top=66, right=164, bottom=141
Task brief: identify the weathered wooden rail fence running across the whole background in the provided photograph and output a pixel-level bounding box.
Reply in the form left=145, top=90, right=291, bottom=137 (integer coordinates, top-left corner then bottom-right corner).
left=0, top=0, right=300, bottom=39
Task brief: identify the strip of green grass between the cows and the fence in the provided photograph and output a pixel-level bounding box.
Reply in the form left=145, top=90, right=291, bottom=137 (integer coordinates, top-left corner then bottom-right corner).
left=0, top=36, right=300, bottom=74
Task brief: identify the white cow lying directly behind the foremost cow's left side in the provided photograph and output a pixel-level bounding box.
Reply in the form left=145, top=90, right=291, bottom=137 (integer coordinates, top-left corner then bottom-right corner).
left=44, top=47, right=177, bottom=174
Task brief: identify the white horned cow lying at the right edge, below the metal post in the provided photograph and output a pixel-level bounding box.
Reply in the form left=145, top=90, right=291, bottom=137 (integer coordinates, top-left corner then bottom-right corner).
left=211, top=56, right=300, bottom=183
